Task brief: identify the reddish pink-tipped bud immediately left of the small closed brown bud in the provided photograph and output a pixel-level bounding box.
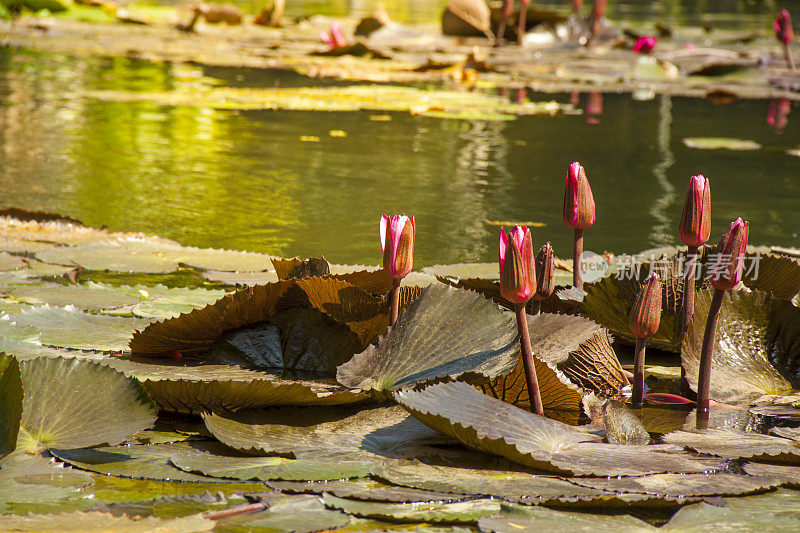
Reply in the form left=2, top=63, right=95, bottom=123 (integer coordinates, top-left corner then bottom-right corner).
left=499, top=226, right=536, bottom=303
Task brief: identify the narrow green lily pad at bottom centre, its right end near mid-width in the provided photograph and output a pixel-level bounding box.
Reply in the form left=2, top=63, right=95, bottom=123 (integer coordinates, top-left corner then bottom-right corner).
left=322, top=494, right=500, bottom=524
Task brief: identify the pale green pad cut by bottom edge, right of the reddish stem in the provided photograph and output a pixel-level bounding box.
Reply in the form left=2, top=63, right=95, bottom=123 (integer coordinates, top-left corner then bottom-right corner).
left=215, top=496, right=351, bottom=533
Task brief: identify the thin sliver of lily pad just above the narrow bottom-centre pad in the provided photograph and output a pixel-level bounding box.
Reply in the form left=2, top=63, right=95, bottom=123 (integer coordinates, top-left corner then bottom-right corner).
left=268, top=479, right=469, bottom=503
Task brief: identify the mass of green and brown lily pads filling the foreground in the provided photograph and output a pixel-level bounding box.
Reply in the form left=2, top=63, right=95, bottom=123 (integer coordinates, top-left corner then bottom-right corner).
left=0, top=206, right=800, bottom=531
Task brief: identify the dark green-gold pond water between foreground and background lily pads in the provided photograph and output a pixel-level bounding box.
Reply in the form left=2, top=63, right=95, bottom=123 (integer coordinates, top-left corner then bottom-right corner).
left=0, top=49, right=800, bottom=265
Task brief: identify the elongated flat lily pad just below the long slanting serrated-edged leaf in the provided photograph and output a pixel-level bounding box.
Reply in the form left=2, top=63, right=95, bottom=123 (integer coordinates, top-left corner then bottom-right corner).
left=377, top=462, right=603, bottom=504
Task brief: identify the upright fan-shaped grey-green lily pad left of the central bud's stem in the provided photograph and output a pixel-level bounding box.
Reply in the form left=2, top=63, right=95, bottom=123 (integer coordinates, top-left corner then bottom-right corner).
left=336, top=284, right=519, bottom=391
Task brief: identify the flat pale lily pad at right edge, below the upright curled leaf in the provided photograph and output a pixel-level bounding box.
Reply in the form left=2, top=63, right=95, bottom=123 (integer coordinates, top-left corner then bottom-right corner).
left=662, top=429, right=800, bottom=463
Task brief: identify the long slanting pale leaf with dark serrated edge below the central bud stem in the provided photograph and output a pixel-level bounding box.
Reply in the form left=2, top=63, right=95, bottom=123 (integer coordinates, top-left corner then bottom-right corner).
left=394, top=382, right=724, bottom=476
